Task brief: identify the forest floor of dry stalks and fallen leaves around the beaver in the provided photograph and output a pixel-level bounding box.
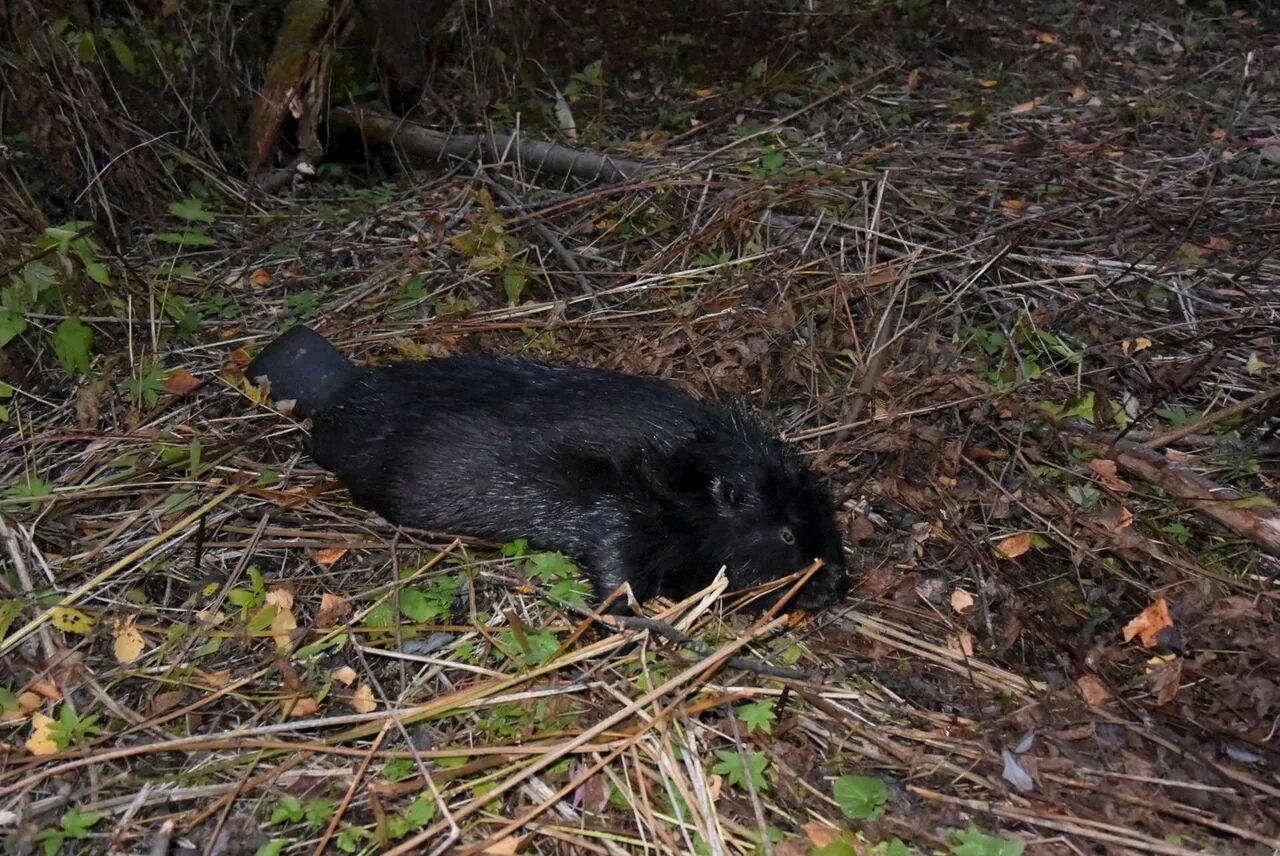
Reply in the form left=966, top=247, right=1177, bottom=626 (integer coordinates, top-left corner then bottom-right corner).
left=0, top=3, right=1280, bottom=856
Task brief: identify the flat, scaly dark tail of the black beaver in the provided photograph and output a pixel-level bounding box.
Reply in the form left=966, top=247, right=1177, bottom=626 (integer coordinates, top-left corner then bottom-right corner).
left=244, top=324, right=360, bottom=418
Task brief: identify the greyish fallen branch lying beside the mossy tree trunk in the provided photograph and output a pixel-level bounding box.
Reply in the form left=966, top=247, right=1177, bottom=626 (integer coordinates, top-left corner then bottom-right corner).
left=329, top=107, right=644, bottom=184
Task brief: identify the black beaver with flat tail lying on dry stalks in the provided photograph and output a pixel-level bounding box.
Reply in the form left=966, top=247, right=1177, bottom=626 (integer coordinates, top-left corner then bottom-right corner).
left=244, top=326, right=845, bottom=609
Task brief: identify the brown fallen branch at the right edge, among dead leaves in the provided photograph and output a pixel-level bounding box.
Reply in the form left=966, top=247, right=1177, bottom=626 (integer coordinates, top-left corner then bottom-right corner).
left=1065, top=430, right=1280, bottom=558
